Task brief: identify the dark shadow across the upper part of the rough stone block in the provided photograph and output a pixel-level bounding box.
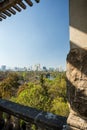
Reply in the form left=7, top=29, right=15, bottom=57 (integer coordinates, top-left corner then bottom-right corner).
left=67, top=42, right=87, bottom=75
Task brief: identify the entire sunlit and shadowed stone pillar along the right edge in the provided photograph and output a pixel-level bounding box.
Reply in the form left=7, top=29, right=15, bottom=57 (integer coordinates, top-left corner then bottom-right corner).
left=66, top=0, right=87, bottom=130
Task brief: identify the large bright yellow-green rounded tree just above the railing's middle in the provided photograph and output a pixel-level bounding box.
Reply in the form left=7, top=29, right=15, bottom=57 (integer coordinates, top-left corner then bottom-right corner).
left=13, top=83, right=50, bottom=111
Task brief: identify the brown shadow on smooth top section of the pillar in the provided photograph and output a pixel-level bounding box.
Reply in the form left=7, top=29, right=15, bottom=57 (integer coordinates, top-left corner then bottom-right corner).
left=69, top=0, right=87, bottom=33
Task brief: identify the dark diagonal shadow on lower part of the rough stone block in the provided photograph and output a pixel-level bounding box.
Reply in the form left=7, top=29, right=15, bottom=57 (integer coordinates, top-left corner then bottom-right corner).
left=67, top=79, right=87, bottom=117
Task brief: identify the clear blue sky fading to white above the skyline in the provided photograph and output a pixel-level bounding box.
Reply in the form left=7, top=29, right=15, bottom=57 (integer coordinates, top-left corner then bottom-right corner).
left=0, top=0, right=69, bottom=68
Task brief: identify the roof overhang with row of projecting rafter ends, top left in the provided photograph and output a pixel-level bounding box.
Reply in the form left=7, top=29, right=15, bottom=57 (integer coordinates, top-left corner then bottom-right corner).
left=0, top=0, right=40, bottom=21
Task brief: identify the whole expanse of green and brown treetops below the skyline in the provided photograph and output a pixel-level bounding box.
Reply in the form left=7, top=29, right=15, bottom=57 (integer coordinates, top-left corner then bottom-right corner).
left=0, top=71, right=69, bottom=117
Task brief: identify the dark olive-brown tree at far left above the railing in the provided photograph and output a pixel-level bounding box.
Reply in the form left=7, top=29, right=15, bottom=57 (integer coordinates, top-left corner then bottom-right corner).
left=0, top=73, right=19, bottom=99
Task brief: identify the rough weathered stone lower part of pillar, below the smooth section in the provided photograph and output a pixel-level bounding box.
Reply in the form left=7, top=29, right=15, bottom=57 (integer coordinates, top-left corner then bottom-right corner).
left=67, top=48, right=87, bottom=130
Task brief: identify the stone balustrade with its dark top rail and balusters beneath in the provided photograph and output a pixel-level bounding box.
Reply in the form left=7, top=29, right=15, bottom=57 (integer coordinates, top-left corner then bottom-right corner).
left=0, top=99, right=67, bottom=130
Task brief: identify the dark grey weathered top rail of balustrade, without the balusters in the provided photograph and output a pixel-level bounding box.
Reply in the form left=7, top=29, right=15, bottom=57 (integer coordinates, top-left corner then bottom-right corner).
left=0, top=99, right=67, bottom=130
